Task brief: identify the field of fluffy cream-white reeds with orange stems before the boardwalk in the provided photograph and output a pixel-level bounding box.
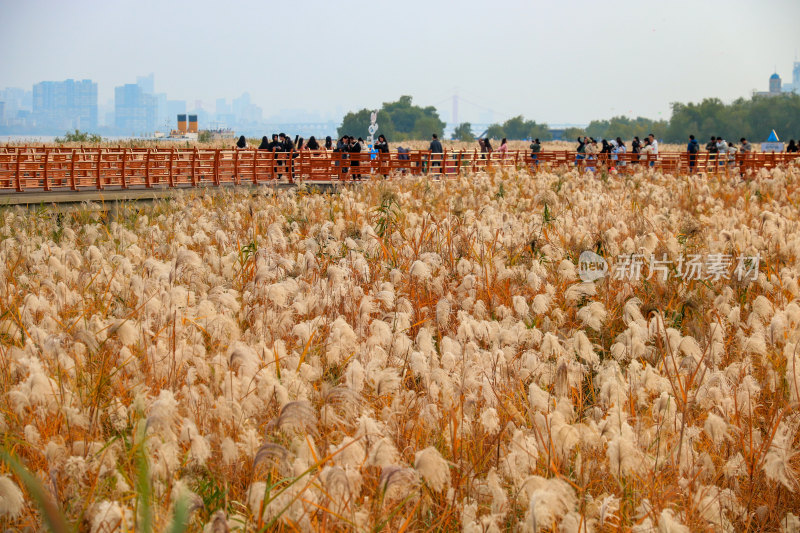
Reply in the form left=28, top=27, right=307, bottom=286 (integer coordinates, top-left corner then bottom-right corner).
left=0, top=163, right=800, bottom=533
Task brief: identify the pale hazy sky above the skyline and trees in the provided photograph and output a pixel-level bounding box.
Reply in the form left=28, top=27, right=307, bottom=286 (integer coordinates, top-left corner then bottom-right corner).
left=0, top=0, right=800, bottom=124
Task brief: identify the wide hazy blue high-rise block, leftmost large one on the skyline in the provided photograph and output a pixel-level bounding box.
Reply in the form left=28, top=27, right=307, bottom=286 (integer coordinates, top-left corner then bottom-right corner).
left=33, top=79, right=97, bottom=130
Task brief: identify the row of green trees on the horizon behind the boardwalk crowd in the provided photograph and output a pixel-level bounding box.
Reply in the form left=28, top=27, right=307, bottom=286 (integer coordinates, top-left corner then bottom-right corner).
left=339, top=94, right=800, bottom=143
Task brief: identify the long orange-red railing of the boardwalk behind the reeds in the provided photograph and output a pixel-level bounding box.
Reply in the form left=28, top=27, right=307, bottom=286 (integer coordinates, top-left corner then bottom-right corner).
left=0, top=146, right=800, bottom=193
